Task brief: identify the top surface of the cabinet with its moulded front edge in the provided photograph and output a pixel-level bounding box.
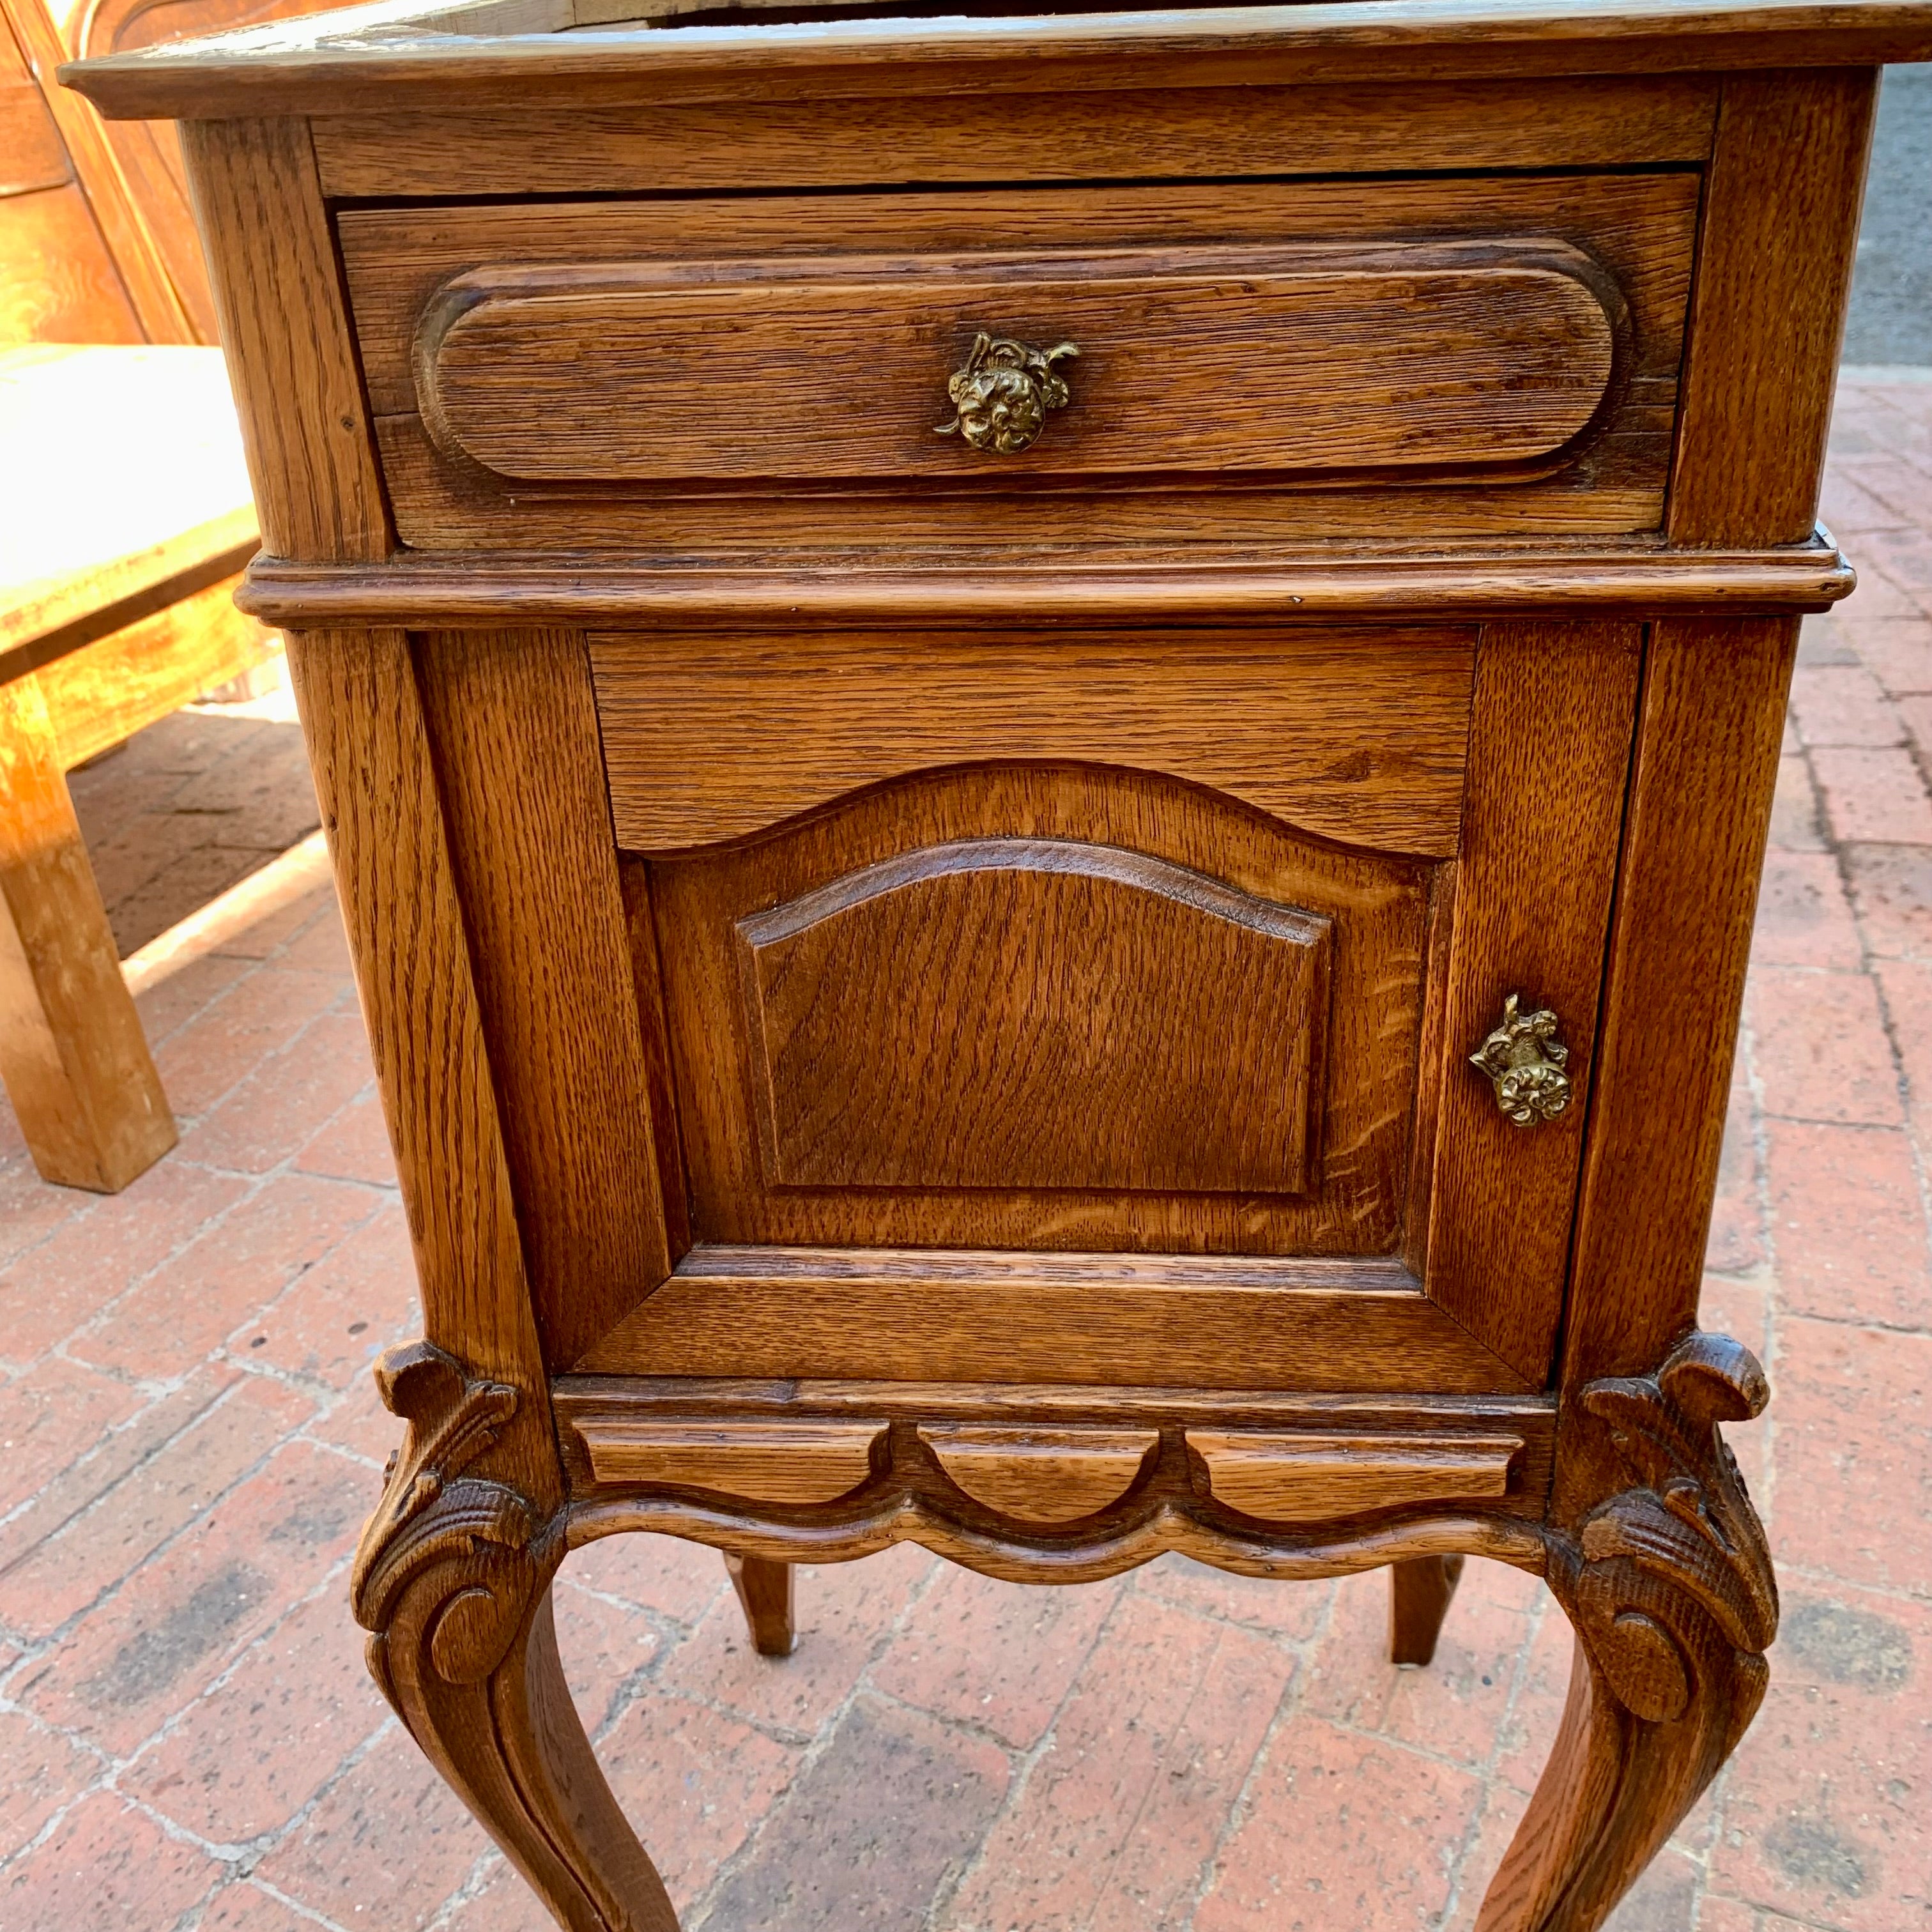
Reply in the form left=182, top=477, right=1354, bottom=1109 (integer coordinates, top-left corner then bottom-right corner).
left=60, top=0, right=1932, bottom=119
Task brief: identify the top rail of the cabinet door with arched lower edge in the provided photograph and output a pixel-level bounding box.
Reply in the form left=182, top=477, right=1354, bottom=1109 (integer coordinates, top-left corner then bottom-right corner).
left=589, top=626, right=1474, bottom=858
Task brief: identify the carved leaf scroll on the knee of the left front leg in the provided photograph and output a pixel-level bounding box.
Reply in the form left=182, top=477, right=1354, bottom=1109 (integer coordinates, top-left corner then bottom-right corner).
left=349, top=1341, right=541, bottom=1715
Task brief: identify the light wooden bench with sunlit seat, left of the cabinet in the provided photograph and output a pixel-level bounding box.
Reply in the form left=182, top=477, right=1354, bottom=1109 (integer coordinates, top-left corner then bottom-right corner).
left=0, top=344, right=274, bottom=1192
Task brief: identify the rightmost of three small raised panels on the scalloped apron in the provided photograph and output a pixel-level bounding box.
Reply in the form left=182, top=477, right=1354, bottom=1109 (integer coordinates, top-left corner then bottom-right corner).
left=1186, top=1430, right=1522, bottom=1522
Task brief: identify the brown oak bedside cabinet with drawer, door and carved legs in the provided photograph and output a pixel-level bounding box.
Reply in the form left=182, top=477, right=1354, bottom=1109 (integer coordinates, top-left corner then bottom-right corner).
left=70, top=0, right=1932, bottom=1932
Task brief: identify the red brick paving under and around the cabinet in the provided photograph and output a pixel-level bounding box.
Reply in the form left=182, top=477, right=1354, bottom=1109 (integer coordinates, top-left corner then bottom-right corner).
left=0, top=369, right=1932, bottom=1932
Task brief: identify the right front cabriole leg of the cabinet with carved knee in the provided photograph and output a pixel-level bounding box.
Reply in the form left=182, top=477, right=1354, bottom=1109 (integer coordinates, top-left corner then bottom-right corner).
left=1476, top=1335, right=1777, bottom=1932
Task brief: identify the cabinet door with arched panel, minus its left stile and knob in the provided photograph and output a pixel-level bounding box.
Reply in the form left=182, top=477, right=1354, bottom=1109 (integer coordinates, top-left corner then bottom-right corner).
left=576, top=624, right=1638, bottom=1393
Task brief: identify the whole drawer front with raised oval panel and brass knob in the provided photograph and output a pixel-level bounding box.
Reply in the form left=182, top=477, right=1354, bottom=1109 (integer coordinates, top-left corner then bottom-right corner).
left=340, top=174, right=1696, bottom=551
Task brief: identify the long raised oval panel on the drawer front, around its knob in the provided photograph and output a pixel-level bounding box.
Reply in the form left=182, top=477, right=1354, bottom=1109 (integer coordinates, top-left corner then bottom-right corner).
left=415, top=238, right=1623, bottom=483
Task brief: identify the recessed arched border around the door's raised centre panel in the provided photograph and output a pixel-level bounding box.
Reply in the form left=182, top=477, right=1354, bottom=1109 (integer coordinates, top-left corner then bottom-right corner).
left=651, top=763, right=1429, bottom=1254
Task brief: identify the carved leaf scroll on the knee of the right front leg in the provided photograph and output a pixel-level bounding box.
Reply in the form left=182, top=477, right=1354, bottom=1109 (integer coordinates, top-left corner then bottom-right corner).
left=1551, top=1333, right=1777, bottom=1723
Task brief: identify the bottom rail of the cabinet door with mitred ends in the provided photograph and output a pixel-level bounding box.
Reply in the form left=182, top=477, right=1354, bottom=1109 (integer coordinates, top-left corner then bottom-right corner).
left=576, top=1246, right=1524, bottom=1395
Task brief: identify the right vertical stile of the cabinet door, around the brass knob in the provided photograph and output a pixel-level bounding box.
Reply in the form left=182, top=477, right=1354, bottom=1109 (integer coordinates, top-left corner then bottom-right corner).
left=1424, top=622, right=1640, bottom=1381
